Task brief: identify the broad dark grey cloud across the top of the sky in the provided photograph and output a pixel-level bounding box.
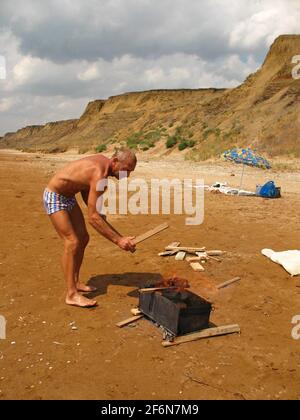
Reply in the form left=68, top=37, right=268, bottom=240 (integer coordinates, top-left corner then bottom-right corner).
left=1, top=0, right=287, bottom=63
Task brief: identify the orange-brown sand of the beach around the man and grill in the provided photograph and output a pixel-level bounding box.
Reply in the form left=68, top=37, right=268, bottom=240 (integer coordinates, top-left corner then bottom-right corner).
left=0, top=152, right=300, bottom=400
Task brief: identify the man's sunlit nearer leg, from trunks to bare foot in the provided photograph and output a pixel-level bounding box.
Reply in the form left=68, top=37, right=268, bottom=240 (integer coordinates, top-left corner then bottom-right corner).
left=50, top=210, right=97, bottom=307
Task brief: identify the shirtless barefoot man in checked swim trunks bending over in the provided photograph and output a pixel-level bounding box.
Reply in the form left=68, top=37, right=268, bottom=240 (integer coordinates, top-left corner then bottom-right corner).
left=44, top=149, right=137, bottom=308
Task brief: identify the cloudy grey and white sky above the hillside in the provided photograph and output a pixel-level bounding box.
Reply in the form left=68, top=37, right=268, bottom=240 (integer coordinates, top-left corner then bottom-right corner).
left=0, top=0, right=300, bottom=136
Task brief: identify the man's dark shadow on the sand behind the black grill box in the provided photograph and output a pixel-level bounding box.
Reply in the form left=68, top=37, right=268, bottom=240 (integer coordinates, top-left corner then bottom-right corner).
left=85, top=273, right=162, bottom=299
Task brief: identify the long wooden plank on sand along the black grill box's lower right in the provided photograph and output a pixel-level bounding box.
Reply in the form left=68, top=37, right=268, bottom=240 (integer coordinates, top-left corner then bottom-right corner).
left=162, top=324, right=241, bottom=347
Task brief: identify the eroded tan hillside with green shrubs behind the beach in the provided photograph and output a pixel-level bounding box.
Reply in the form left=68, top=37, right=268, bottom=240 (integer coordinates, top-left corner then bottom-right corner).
left=0, top=35, right=300, bottom=160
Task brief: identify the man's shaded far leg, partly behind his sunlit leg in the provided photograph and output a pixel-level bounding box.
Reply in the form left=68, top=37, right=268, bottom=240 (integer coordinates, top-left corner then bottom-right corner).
left=70, top=204, right=97, bottom=292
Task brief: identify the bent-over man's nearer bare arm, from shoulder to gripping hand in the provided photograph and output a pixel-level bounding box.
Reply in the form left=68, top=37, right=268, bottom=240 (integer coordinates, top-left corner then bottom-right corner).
left=88, top=179, right=135, bottom=252
